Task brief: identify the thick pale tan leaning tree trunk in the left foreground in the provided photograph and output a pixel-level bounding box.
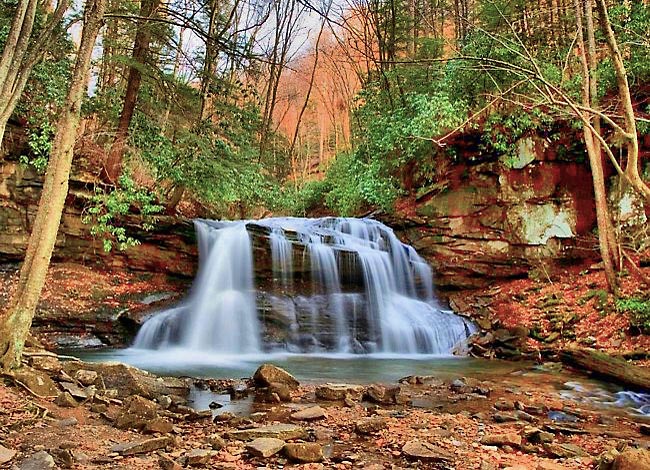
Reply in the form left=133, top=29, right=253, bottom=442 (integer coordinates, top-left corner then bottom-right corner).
left=0, top=0, right=105, bottom=371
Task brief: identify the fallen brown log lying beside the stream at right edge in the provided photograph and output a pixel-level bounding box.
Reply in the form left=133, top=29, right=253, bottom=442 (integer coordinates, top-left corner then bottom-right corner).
left=560, top=349, right=650, bottom=390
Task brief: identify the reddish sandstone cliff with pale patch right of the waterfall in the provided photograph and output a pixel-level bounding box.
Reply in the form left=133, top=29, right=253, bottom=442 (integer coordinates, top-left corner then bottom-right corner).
left=383, top=151, right=596, bottom=288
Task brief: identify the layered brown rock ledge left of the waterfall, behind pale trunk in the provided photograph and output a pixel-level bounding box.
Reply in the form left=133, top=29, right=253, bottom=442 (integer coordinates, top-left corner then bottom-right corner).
left=0, top=160, right=196, bottom=277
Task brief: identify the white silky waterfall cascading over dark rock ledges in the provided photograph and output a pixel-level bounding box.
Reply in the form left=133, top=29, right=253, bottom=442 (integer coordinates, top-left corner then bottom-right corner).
left=134, top=218, right=474, bottom=354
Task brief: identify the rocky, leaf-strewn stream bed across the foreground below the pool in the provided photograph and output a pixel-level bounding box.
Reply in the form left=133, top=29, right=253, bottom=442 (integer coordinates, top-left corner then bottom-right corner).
left=0, top=351, right=650, bottom=470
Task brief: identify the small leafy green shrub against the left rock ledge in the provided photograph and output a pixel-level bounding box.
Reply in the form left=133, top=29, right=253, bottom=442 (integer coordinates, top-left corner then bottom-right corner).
left=82, top=174, right=163, bottom=252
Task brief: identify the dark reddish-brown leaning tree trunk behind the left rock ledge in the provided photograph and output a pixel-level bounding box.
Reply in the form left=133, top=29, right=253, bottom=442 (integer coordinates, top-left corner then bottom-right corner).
left=103, top=0, right=160, bottom=184
